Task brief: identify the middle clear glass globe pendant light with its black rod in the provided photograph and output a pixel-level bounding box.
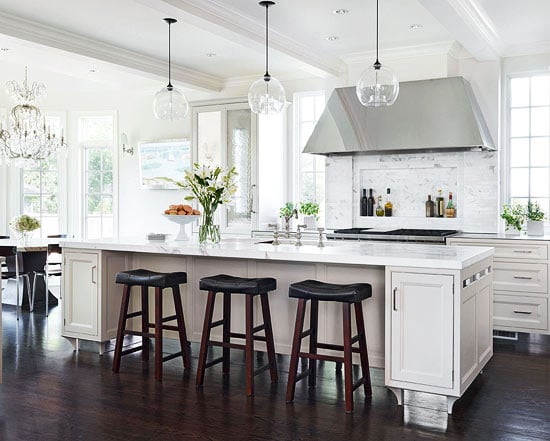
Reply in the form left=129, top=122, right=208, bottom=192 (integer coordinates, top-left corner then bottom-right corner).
left=248, top=1, right=286, bottom=115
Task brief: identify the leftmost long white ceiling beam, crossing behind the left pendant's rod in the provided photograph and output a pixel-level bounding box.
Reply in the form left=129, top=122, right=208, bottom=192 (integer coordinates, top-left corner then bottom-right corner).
left=0, top=12, right=224, bottom=92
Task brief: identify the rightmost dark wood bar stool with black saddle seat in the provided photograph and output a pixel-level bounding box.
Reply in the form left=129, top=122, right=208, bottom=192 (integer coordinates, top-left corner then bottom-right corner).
left=286, top=280, right=372, bottom=413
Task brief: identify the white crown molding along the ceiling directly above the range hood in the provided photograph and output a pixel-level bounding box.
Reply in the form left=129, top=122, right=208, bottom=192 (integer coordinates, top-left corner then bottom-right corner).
left=342, top=41, right=455, bottom=64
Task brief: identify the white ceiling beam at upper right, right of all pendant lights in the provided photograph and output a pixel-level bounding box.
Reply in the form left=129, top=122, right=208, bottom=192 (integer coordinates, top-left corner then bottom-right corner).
left=418, top=0, right=504, bottom=61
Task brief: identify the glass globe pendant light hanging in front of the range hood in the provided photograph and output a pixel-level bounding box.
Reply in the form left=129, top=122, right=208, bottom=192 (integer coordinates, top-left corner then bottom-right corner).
left=356, top=0, right=399, bottom=107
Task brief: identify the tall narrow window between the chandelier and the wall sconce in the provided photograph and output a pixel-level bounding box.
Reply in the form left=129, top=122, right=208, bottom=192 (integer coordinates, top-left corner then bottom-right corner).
left=78, top=115, right=114, bottom=239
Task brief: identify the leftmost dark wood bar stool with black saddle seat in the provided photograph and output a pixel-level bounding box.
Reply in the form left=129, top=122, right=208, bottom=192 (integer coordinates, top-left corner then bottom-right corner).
left=113, top=269, right=191, bottom=380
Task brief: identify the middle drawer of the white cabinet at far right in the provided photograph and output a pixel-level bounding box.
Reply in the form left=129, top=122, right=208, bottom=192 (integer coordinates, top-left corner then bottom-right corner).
left=493, top=262, right=548, bottom=294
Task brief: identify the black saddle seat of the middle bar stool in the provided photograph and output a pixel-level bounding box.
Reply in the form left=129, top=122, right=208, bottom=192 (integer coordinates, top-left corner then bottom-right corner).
left=199, top=274, right=277, bottom=295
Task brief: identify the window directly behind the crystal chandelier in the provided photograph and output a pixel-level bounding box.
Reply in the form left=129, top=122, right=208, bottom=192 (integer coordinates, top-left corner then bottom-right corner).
left=21, top=116, right=61, bottom=237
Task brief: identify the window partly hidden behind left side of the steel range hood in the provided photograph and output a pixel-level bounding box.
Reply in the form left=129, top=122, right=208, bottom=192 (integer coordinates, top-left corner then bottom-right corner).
left=294, top=91, right=325, bottom=218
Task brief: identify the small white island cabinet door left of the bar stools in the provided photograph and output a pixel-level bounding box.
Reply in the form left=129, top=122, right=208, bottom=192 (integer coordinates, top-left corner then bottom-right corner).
left=63, top=253, right=99, bottom=336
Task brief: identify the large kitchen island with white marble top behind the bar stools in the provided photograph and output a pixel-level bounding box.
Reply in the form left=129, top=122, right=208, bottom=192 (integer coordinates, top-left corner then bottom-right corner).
left=61, top=238, right=493, bottom=412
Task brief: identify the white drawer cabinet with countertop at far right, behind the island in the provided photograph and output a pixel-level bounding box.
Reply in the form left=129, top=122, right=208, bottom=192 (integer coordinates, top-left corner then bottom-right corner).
left=448, top=238, right=550, bottom=334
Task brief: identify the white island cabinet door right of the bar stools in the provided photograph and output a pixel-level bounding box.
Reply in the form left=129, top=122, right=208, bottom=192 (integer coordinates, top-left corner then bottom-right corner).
left=391, top=273, right=453, bottom=388
